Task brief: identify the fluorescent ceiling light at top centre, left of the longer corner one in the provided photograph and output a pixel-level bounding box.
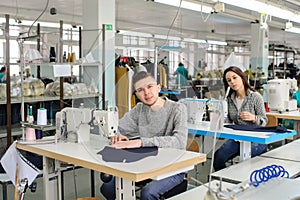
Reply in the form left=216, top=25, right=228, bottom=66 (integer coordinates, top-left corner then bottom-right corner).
left=154, top=0, right=213, bottom=13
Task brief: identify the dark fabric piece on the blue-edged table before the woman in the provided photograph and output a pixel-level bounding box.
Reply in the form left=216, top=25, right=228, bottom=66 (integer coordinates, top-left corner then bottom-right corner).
left=224, top=124, right=290, bottom=133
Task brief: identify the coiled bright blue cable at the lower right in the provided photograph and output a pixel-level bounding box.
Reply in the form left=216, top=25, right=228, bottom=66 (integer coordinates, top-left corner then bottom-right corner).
left=250, top=165, right=289, bottom=187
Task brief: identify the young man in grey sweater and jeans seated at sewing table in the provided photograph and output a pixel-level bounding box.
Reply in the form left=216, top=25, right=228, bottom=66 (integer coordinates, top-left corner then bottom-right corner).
left=101, top=71, right=188, bottom=200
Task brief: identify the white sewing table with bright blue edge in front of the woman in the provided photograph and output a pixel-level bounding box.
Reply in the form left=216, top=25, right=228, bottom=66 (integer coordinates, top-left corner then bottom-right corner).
left=188, top=121, right=296, bottom=161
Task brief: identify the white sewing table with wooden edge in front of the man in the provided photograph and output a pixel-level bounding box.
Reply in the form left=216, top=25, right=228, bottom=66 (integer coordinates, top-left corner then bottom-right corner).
left=16, top=136, right=206, bottom=200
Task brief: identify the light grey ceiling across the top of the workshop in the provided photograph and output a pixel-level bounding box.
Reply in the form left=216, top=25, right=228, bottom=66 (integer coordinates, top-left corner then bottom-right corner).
left=0, top=0, right=300, bottom=49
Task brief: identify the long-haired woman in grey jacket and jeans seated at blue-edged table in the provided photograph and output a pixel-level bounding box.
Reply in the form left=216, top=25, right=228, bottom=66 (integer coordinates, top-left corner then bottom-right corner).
left=213, top=66, right=268, bottom=171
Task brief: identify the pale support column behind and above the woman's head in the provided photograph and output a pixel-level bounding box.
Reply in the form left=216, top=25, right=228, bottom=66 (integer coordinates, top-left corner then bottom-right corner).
left=250, top=23, right=269, bottom=77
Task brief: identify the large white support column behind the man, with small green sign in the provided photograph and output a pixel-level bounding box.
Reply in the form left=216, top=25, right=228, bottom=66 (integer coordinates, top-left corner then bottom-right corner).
left=82, top=0, right=116, bottom=107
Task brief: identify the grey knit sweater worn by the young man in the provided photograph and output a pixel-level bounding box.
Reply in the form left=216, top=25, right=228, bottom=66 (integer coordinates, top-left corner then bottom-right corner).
left=119, top=98, right=188, bottom=149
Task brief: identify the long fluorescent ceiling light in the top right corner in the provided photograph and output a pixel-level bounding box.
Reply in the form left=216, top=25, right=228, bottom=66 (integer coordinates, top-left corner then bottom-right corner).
left=220, top=0, right=300, bottom=23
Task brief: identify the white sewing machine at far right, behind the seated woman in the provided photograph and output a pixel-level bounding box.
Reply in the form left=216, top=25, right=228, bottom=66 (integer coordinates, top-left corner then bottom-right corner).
left=267, top=79, right=297, bottom=112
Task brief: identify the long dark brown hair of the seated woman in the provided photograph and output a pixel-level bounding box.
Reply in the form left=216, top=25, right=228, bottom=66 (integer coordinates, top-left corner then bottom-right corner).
left=223, top=66, right=254, bottom=96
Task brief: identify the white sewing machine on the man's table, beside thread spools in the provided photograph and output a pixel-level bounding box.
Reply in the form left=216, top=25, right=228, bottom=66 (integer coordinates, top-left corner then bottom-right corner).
left=56, top=107, right=119, bottom=142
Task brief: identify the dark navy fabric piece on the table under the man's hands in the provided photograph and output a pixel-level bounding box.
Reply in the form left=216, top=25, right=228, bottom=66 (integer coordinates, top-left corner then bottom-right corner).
left=97, top=146, right=158, bottom=163
